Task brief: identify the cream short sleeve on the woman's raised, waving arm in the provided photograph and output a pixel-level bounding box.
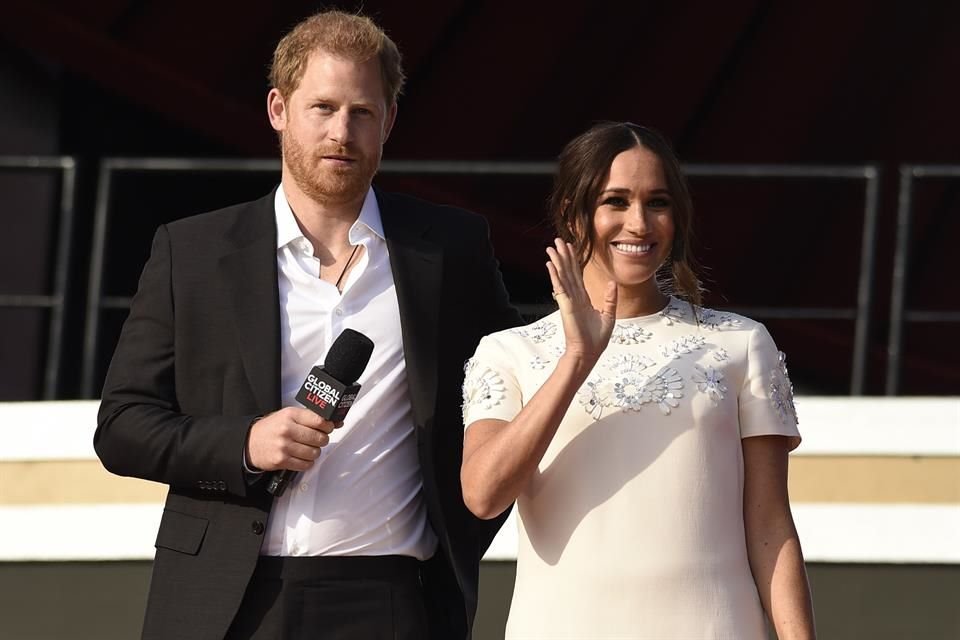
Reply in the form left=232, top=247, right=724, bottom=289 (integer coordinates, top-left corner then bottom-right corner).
left=463, top=336, right=523, bottom=427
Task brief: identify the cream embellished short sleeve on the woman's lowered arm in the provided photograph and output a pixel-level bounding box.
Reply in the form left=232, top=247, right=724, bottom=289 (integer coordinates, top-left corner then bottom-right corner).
left=739, top=324, right=800, bottom=450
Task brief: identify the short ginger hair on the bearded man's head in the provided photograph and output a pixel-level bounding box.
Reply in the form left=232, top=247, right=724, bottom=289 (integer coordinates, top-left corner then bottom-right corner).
left=270, top=11, right=404, bottom=106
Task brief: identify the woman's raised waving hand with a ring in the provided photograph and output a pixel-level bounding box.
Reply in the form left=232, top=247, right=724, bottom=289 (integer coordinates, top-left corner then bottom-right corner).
left=547, top=238, right=617, bottom=362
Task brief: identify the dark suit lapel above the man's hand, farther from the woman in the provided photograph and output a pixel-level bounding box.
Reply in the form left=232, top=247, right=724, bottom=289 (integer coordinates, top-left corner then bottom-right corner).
left=220, top=193, right=280, bottom=413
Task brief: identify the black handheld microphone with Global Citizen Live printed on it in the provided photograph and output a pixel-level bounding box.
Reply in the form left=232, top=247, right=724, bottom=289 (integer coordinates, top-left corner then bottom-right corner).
left=267, top=329, right=373, bottom=497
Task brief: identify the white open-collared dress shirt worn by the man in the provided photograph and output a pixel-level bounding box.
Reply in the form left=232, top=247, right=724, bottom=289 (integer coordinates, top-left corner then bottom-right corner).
left=261, top=186, right=437, bottom=560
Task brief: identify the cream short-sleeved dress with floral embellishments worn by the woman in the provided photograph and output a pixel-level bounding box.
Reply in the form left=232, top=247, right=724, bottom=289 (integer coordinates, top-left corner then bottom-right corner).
left=463, top=298, right=800, bottom=640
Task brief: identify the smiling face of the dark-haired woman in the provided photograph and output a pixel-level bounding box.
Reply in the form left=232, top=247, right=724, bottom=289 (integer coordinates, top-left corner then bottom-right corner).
left=587, top=146, right=674, bottom=293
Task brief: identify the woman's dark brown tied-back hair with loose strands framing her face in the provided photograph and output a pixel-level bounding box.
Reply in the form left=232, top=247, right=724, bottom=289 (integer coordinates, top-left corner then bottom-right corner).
left=550, top=122, right=703, bottom=306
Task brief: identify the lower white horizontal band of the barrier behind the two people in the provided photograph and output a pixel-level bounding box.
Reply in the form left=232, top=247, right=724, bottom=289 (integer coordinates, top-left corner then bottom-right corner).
left=0, top=504, right=960, bottom=564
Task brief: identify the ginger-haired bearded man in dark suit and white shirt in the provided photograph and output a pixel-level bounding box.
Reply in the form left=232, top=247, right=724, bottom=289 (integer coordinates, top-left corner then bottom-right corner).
left=94, top=11, right=519, bottom=640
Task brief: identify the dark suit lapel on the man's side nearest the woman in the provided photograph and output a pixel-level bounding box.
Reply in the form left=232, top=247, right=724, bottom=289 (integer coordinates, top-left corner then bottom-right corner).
left=376, top=190, right=443, bottom=428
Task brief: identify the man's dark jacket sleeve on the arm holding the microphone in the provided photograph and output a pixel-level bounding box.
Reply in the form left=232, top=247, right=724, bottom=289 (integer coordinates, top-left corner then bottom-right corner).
left=93, top=226, right=255, bottom=496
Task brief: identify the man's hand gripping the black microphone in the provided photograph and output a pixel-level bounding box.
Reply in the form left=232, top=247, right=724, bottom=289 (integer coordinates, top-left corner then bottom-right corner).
left=246, top=407, right=343, bottom=471
